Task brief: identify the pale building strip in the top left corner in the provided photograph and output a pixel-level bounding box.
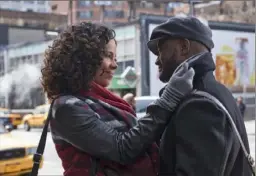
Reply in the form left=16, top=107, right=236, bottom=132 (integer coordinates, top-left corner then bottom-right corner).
left=0, top=0, right=51, bottom=13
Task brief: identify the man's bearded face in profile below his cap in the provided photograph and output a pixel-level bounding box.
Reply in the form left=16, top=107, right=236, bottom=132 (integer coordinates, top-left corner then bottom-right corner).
left=155, top=39, right=183, bottom=82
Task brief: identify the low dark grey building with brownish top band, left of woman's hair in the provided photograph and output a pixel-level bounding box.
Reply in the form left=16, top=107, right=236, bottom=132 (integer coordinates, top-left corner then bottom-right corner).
left=0, top=9, right=67, bottom=48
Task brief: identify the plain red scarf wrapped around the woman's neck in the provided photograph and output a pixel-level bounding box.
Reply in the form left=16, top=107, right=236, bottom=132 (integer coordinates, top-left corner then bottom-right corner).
left=81, top=82, right=136, bottom=116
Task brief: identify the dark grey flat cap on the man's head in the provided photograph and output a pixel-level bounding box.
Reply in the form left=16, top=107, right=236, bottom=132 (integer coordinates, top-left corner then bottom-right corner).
left=147, top=17, right=214, bottom=55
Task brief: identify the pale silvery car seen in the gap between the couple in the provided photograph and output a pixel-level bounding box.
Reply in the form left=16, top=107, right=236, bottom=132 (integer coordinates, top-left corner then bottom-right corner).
left=135, top=96, right=159, bottom=119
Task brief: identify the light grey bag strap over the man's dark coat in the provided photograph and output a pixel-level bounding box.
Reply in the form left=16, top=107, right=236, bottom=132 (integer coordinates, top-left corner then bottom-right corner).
left=192, top=90, right=255, bottom=176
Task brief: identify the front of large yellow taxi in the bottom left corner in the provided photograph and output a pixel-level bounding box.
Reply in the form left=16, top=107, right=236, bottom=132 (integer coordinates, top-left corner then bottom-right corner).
left=0, top=123, right=43, bottom=176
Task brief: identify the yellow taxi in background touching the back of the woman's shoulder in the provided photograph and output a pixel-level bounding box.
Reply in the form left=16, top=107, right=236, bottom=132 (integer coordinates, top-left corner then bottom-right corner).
left=23, top=104, right=50, bottom=131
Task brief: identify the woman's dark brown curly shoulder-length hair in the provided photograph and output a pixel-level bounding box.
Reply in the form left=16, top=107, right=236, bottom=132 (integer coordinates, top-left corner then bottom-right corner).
left=41, top=22, right=115, bottom=99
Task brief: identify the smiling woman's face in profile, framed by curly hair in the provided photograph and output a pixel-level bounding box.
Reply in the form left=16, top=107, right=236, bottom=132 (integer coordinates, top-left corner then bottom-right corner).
left=94, top=39, right=117, bottom=87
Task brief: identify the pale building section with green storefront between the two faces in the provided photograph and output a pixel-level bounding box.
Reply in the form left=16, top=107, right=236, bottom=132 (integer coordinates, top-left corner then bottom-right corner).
left=108, top=23, right=140, bottom=96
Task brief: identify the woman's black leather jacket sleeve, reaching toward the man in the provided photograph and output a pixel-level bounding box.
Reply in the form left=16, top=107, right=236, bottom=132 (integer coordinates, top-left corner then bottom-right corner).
left=53, top=96, right=170, bottom=164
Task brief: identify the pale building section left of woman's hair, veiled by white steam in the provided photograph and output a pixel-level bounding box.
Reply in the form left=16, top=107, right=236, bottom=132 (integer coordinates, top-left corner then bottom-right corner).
left=0, top=40, right=52, bottom=109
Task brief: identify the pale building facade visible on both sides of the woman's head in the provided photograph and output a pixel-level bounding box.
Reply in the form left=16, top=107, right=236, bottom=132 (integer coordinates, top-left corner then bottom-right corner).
left=0, top=23, right=140, bottom=108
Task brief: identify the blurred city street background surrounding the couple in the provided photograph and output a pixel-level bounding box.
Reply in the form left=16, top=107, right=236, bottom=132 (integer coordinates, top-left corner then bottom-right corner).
left=0, top=0, right=256, bottom=176
